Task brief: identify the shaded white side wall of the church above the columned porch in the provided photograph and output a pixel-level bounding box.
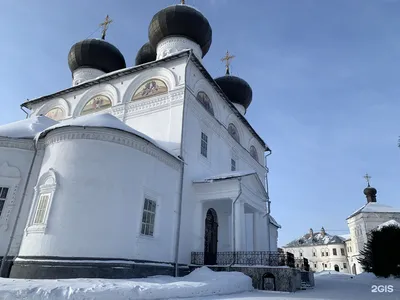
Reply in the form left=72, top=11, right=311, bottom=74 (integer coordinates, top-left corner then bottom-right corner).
left=179, top=68, right=268, bottom=263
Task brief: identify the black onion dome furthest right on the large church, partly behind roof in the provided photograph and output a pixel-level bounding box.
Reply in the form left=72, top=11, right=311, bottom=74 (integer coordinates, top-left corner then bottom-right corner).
left=214, top=75, right=253, bottom=109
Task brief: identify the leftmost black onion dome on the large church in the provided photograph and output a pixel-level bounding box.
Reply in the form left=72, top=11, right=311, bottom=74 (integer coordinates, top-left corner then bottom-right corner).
left=68, top=39, right=126, bottom=73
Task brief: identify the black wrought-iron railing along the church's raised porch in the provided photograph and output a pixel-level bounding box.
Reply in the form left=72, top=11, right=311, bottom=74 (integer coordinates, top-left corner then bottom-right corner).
left=191, top=251, right=294, bottom=268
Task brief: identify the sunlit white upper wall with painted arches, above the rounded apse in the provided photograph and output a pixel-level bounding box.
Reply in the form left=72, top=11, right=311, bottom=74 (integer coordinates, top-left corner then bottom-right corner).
left=31, top=58, right=187, bottom=152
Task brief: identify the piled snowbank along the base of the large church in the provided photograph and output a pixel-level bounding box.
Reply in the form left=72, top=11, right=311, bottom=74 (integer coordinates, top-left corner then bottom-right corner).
left=0, top=267, right=253, bottom=300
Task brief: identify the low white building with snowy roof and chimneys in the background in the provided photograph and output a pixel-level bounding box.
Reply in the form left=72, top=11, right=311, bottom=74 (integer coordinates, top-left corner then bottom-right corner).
left=283, top=227, right=349, bottom=273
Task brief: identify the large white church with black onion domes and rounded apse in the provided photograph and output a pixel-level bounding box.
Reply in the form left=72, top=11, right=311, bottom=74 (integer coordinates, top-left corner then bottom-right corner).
left=0, top=5, right=280, bottom=278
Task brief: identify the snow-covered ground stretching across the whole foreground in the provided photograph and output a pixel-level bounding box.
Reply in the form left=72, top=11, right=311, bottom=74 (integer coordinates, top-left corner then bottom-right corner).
left=0, top=268, right=400, bottom=300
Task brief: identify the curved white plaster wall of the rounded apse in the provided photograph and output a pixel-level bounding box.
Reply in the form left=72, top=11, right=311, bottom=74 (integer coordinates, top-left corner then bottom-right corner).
left=19, top=128, right=179, bottom=261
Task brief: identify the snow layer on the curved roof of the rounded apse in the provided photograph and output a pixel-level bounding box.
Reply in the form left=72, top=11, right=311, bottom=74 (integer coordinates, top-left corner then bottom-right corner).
left=35, top=113, right=177, bottom=158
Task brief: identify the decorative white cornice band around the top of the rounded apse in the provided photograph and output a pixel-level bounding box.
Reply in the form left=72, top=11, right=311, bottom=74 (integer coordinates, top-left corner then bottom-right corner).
left=44, top=127, right=180, bottom=170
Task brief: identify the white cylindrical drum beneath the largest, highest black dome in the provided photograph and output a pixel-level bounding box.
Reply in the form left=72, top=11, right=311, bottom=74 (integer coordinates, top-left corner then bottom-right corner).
left=157, top=36, right=203, bottom=62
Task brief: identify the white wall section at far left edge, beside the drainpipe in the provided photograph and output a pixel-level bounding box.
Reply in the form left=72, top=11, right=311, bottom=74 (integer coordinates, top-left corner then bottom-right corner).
left=0, top=138, right=40, bottom=256
